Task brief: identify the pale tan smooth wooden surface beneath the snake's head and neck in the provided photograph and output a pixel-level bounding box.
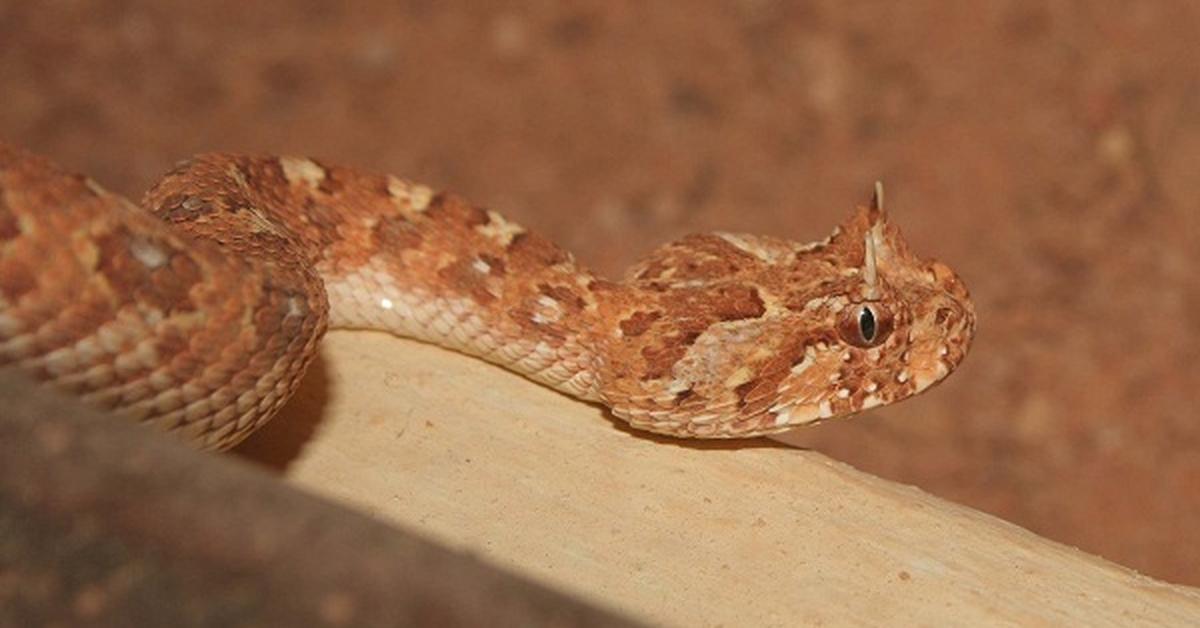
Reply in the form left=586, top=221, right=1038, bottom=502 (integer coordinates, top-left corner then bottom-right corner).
left=241, top=333, right=1200, bottom=626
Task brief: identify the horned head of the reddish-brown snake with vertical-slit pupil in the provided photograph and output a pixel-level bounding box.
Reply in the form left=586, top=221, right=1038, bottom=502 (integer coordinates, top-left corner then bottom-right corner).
left=600, top=189, right=974, bottom=437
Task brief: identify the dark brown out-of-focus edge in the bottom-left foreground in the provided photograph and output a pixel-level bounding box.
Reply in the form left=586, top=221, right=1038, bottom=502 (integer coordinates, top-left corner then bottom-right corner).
left=0, top=373, right=629, bottom=626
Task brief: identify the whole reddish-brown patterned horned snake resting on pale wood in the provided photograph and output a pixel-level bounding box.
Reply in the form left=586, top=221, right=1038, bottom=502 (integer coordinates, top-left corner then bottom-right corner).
left=0, top=142, right=976, bottom=449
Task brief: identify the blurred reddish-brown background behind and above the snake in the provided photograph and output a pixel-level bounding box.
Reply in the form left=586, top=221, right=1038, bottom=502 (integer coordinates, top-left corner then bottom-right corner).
left=0, top=0, right=1200, bottom=585
